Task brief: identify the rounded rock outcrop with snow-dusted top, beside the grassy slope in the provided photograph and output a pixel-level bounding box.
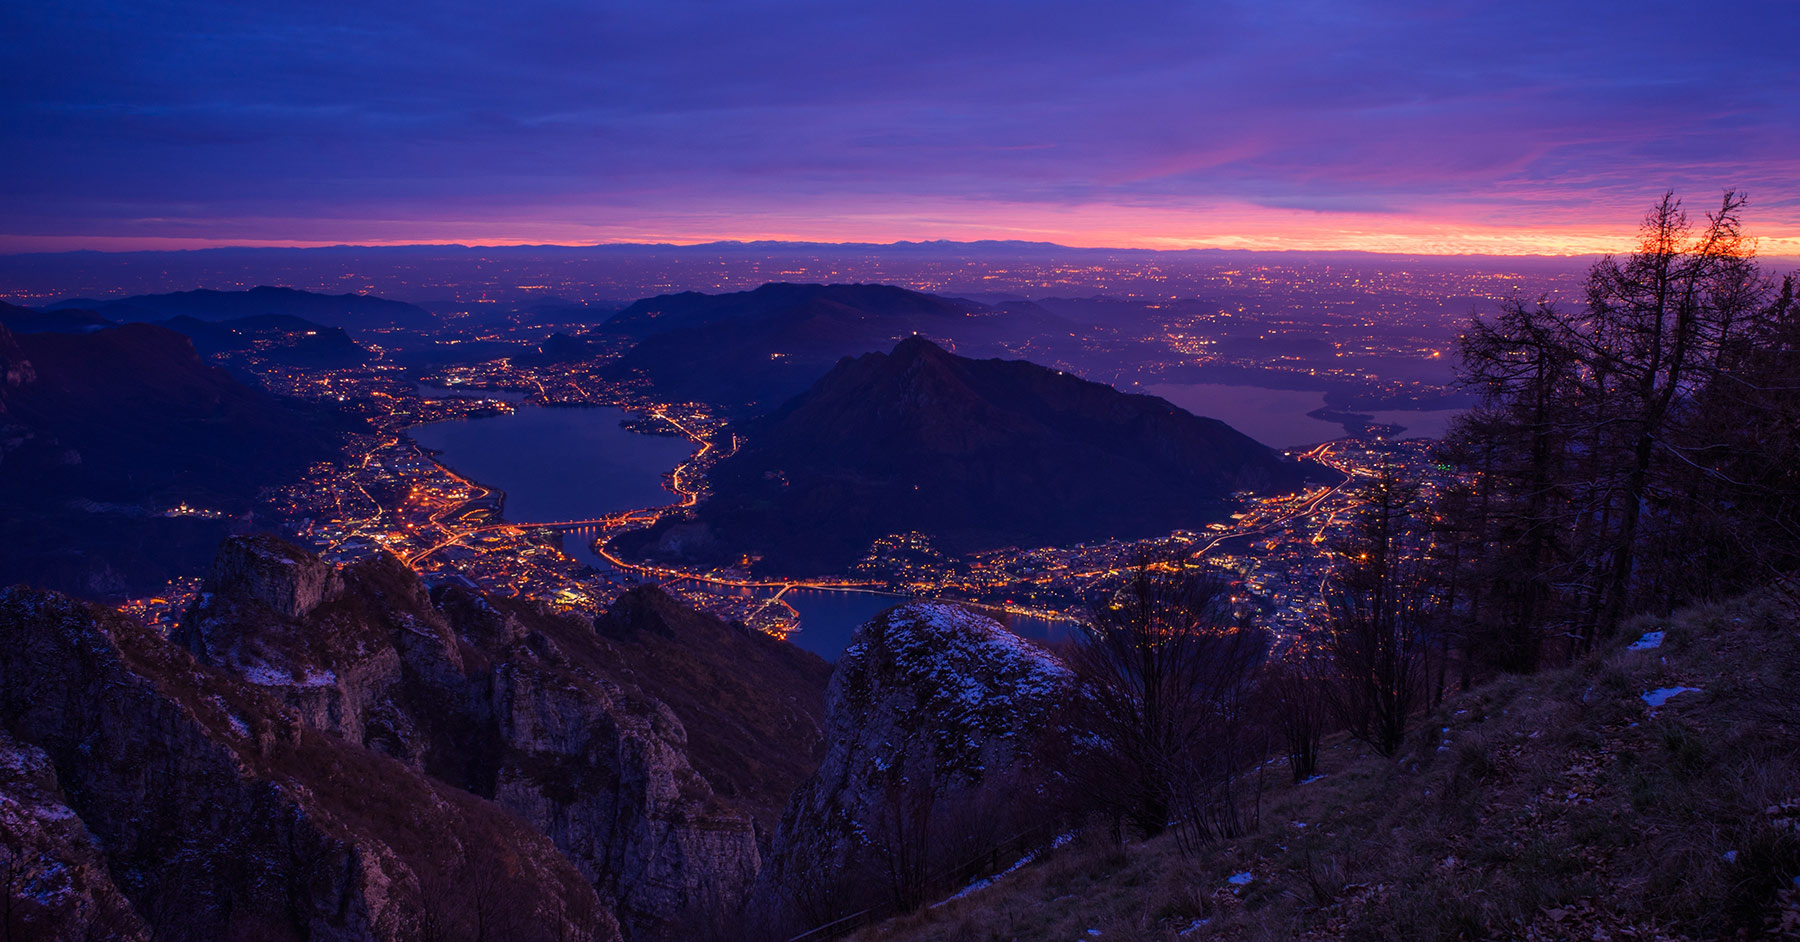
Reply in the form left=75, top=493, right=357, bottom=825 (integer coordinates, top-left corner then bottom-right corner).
left=765, top=603, right=1073, bottom=919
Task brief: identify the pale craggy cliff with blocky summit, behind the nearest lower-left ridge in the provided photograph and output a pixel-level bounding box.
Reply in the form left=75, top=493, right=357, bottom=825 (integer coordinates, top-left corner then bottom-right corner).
left=180, top=537, right=774, bottom=938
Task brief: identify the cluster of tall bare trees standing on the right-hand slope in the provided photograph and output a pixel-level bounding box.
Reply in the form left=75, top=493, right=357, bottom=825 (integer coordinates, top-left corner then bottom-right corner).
left=1438, top=193, right=1778, bottom=670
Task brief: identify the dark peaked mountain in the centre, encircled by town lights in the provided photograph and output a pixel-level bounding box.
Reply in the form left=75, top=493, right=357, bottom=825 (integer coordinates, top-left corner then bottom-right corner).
left=619, top=337, right=1307, bottom=575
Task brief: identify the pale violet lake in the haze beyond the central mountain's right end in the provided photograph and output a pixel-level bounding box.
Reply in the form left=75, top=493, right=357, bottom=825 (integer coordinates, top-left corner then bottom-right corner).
left=1143, top=384, right=1458, bottom=448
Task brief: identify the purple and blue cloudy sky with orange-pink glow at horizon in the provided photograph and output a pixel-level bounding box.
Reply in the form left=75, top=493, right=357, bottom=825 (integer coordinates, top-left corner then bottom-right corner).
left=0, top=0, right=1800, bottom=256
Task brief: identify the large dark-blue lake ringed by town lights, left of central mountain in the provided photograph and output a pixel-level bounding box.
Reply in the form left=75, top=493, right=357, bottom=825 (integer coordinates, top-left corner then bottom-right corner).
left=409, top=405, right=695, bottom=524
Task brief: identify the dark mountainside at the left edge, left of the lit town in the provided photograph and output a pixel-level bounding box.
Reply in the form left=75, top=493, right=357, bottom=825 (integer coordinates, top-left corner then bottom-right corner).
left=0, top=324, right=355, bottom=596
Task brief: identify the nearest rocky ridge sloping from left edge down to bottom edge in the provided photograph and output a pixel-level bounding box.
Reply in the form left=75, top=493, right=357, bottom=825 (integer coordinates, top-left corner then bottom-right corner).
left=0, top=589, right=617, bottom=940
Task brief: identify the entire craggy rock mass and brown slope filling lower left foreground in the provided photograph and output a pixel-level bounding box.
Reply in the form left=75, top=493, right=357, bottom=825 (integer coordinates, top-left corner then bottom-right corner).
left=0, top=537, right=826, bottom=940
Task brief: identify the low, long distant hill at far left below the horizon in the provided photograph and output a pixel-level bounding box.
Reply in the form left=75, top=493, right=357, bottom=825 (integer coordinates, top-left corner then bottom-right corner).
left=45, top=286, right=437, bottom=330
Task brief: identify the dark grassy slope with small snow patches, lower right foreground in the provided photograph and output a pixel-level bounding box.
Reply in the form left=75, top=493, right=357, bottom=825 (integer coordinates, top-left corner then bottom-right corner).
left=859, top=598, right=1800, bottom=940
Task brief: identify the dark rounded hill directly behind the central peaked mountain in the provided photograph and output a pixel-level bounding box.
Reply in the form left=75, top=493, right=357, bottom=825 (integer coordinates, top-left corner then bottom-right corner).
left=599, top=283, right=1071, bottom=412
